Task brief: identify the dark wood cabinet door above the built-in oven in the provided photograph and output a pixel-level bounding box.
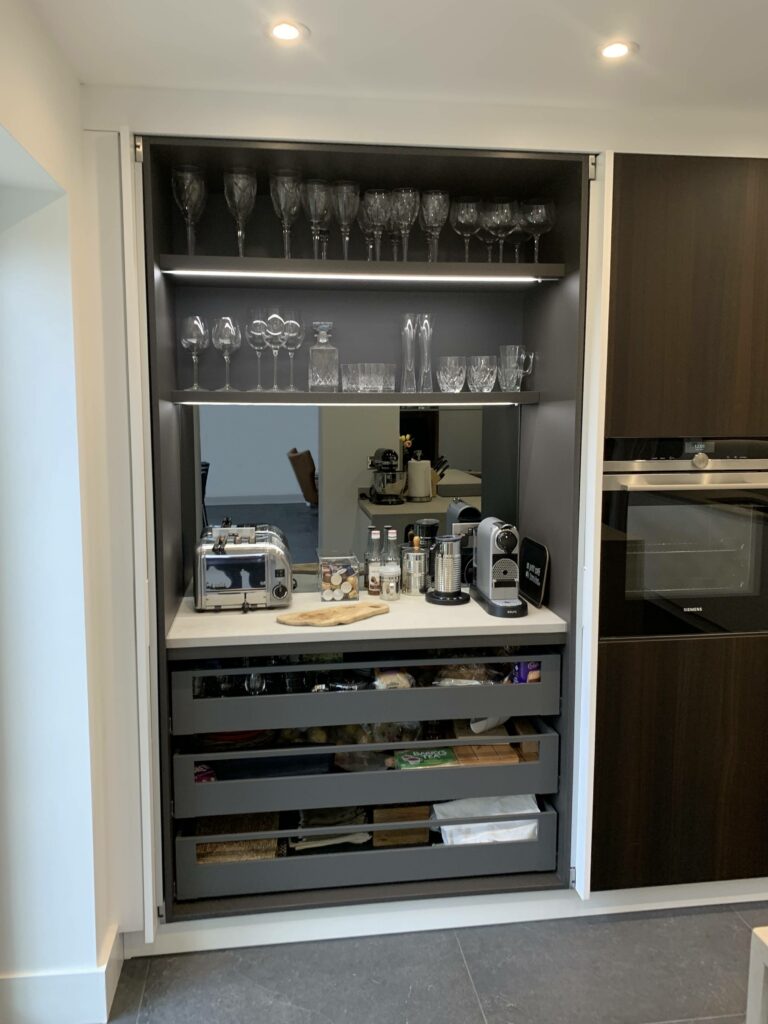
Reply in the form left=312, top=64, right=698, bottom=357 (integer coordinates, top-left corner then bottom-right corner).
left=605, top=155, right=768, bottom=437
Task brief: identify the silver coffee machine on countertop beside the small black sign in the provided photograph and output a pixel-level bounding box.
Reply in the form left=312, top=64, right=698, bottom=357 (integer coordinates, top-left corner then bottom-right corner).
left=472, top=516, right=528, bottom=618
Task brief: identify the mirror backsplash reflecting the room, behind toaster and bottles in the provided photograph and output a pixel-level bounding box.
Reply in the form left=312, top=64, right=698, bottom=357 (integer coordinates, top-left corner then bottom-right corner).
left=199, top=406, right=483, bottom=577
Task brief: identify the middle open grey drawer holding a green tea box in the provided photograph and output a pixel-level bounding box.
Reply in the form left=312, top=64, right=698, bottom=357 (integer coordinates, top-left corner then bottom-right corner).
left=173, top=719, right=560, bottom=818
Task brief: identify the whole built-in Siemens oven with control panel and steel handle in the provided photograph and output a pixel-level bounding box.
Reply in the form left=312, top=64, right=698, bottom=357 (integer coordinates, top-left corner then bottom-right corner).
left=600, top=438, right=768, bottom=637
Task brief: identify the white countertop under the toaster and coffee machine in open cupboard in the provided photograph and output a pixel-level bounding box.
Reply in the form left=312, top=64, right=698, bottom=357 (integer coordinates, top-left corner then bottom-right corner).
left=166, top=593, right=567, bottom=648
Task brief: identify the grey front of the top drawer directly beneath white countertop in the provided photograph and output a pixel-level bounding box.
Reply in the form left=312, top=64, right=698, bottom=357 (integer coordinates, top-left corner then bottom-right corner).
left=171, top=654, right=560, bottom=735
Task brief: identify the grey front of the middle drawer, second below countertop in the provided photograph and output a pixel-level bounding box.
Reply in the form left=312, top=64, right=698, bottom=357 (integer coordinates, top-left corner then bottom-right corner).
left=173, top=721, right=560, bottom=818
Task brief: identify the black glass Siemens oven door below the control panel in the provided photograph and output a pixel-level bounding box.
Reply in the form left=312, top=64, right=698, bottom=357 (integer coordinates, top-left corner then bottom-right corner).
left=600, top=487, right=768, bottom=636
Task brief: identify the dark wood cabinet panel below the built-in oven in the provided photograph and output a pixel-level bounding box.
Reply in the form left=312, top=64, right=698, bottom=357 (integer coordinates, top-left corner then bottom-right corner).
left=592, top=636, right=768, bottom=890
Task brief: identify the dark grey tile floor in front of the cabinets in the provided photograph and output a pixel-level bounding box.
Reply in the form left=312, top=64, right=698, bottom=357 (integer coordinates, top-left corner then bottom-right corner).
left=110, top=903, right=768, bottom=1024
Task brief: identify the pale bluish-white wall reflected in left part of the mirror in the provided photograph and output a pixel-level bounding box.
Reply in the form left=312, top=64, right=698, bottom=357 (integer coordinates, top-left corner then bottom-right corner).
left=200, top=406, right=319, bottom=505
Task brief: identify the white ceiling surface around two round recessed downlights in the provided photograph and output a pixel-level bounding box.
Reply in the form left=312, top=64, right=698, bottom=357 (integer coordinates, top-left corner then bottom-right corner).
left=35, top=0, right=768, bottom=110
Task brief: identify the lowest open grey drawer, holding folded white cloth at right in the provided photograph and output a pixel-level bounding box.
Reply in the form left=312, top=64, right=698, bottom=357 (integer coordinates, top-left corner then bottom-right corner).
left=176, top=801, right=557, bottom=900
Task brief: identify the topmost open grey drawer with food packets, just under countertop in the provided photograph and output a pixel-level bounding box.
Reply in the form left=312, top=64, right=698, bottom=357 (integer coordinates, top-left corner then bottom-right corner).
left=171, top=653, right=560, bottom=735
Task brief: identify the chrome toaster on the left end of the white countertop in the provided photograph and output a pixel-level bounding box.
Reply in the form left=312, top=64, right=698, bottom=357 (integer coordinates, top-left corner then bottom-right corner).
left=195, top=525, right=293, bottom=611
